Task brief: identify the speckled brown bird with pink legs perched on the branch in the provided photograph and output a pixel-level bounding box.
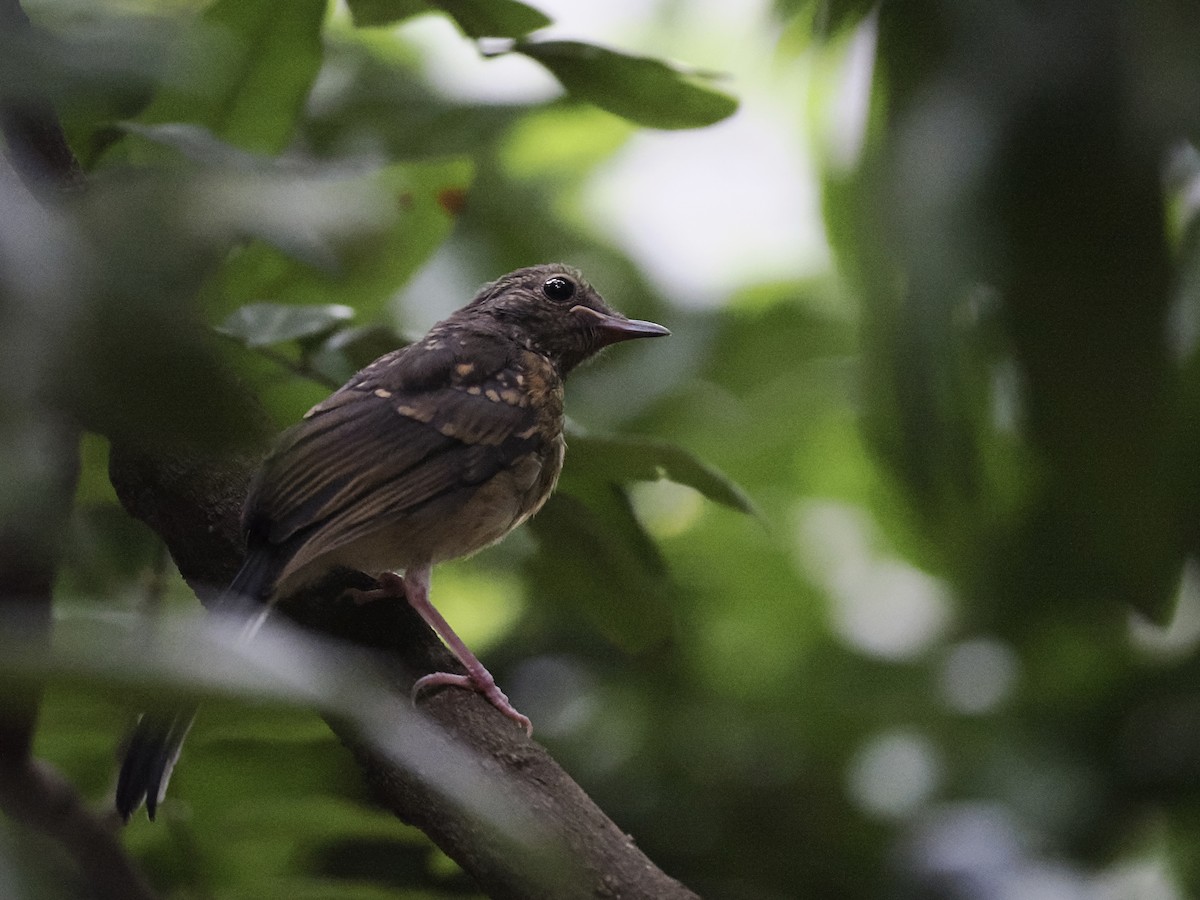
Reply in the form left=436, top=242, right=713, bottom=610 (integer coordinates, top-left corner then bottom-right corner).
left=115, top=263, right=670, bottom=822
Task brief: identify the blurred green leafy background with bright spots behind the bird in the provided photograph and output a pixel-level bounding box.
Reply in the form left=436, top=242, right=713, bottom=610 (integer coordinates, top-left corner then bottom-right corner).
left=0, top=0, right=1200, bottom=900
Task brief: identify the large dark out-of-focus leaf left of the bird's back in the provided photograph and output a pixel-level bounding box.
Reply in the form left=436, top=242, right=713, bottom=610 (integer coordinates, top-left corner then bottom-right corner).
left=31, top=179, right=265, bottom=448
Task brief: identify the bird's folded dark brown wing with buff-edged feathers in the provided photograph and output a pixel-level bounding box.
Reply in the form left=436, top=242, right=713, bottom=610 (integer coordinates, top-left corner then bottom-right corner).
left=246, top=348, right=542, bottom=554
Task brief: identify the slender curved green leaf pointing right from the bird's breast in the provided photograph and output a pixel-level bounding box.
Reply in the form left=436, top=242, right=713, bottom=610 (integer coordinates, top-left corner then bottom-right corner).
left=563, top=434, right=757, bottom=515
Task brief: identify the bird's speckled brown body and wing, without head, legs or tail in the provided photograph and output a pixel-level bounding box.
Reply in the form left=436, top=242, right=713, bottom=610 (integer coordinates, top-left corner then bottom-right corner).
left=245, top=329, right=563, bottom=595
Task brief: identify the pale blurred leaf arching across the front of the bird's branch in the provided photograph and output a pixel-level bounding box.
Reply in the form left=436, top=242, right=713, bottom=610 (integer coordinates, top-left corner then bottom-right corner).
left=11, top=607, right=552, bottom=842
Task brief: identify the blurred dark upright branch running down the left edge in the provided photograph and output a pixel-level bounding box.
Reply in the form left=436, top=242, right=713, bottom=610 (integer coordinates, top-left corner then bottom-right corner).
left=0, top=0, right=154, bottom=900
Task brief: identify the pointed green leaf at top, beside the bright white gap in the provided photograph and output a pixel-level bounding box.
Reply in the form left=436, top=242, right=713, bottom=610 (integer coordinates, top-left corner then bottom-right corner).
left=512, top=41, right=738, bottom=128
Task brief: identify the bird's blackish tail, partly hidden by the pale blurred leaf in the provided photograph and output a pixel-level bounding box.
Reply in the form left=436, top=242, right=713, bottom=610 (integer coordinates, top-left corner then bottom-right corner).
left=116, top=552, right=275, bottom=822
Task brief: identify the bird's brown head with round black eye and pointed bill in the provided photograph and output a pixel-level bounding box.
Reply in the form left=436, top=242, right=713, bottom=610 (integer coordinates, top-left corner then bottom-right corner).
left=467, top=263, right=671, bottom=376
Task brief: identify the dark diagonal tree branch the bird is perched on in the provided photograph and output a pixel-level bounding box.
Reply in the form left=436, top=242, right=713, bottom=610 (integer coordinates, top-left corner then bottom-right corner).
left=109, top=427, right=696, bottom=900
